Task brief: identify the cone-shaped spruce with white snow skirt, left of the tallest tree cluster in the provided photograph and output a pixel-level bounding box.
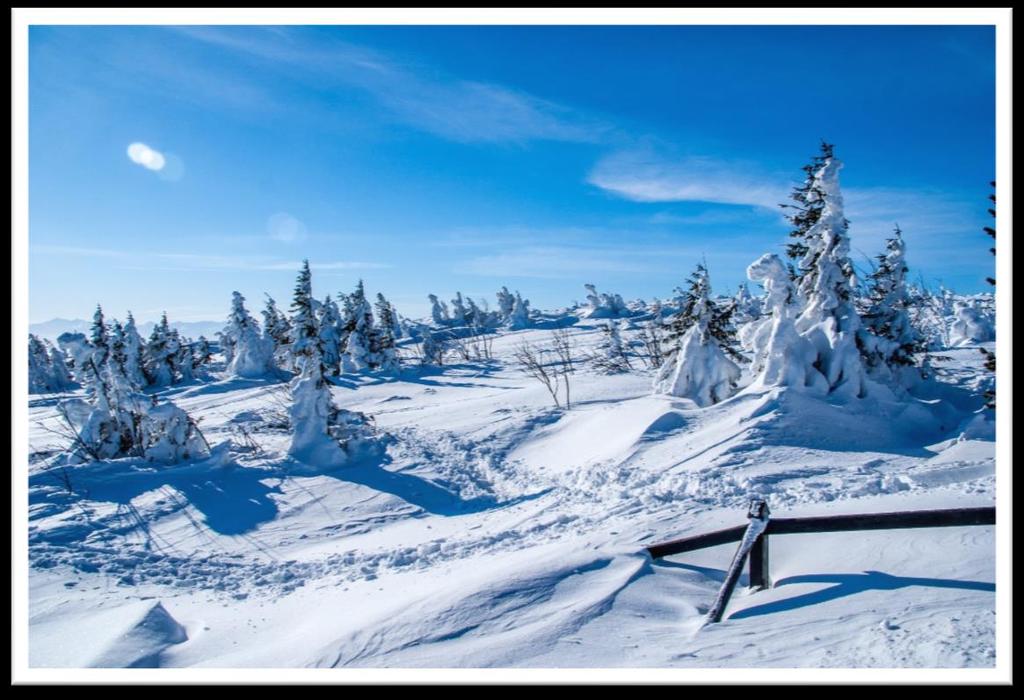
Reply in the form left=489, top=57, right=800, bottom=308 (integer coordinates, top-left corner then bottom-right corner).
left=654, top=265, right=742, bottom=406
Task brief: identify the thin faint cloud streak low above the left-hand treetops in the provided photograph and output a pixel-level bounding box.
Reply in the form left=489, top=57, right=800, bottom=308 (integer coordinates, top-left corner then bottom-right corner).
left=31, top=246, right=391, bottom=272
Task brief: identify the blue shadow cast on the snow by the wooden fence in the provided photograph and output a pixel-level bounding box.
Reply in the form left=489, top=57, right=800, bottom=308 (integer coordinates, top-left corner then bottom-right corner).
left=728, top=571, right=995, bottom=620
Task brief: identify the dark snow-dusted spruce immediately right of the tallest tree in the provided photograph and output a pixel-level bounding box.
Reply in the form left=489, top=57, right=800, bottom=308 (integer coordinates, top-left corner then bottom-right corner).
left=857, top=226, right=925, bottom=387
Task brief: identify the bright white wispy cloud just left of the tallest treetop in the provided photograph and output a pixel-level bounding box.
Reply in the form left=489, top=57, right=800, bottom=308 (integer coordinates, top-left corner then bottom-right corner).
left=587, top=149, right=790, bottom=210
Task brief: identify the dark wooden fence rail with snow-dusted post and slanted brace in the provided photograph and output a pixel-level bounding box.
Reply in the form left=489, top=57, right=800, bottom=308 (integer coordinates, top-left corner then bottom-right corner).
left=645, top=499, right=995, bottom=622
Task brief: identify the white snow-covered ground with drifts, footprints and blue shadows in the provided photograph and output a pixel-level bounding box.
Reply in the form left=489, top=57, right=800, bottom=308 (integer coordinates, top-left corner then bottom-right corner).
left=22, top=320, right=996, bottom=668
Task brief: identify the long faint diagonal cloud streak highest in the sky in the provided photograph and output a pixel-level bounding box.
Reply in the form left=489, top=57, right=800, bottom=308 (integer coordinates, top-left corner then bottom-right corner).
left=176, top=27, right=609, bottom=142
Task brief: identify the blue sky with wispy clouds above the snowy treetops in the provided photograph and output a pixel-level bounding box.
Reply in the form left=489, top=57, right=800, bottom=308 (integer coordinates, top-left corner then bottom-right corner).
left=29, top=27, right=995, bottom=322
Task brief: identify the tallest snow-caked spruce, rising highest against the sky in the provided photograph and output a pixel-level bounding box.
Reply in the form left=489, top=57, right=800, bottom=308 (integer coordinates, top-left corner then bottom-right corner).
left=790, top=143, right=867, bottom=398
